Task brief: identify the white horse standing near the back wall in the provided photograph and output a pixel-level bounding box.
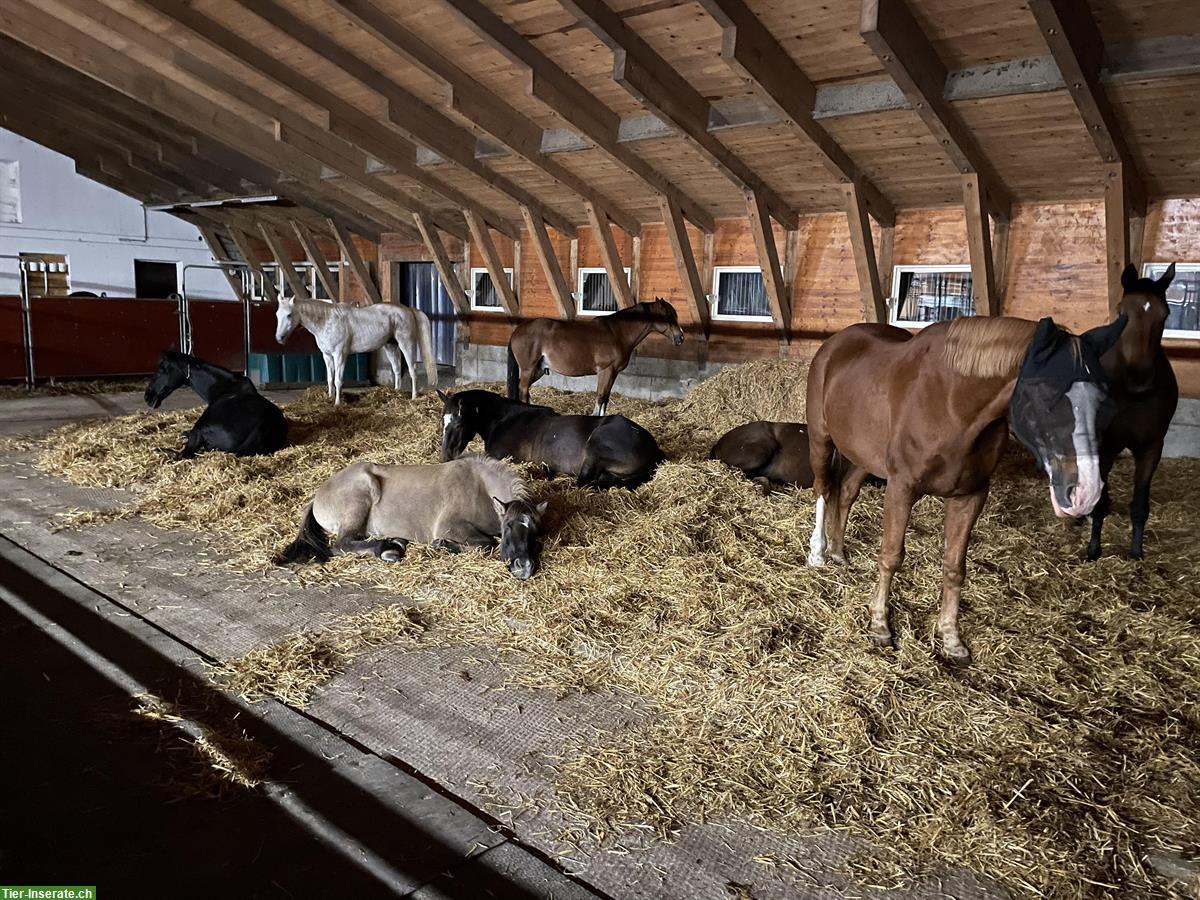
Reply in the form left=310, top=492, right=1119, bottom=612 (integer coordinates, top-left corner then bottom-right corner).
left=275, top=296, right=438, bottom=406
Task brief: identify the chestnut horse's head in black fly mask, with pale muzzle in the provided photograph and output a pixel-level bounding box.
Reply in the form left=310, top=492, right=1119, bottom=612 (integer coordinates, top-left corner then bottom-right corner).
left=1009, top=316, right=1128, bottom=516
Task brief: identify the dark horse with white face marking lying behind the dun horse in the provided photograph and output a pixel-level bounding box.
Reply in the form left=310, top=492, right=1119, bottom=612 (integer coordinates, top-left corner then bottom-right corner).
left=438, top=390, right=665, bottom=488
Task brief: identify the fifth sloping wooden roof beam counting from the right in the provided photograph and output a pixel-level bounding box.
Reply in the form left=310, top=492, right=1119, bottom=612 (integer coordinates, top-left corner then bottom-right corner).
left=440, top=0, right=715, bottom=236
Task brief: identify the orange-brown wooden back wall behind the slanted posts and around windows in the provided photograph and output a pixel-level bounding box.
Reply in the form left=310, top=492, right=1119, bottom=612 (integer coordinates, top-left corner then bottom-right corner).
left=362, top=200, right=1200, bottom=397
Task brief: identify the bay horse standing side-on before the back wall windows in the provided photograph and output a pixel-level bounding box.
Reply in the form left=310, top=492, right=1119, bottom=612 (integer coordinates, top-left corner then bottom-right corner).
left=509, top=298, right=683, bottom=415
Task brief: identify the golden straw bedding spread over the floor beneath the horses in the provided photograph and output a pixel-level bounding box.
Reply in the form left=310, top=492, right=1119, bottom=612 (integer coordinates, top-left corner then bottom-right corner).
left=28, top=361, right=1200, bottom=898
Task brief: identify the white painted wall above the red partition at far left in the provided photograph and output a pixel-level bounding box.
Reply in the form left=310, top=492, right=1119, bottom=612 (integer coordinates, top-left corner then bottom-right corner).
left=0, top=128, right=233, bottom=300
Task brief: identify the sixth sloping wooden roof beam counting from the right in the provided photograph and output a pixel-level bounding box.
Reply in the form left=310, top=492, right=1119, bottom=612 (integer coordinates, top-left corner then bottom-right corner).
left=330, top=0, right=641, bottom=234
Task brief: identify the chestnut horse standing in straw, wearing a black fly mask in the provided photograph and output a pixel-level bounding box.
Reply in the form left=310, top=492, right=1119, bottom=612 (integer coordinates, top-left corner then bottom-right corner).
left=808, top=316, right=1127, bottom=664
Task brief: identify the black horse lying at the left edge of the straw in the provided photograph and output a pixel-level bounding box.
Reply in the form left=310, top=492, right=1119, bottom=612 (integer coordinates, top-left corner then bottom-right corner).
left=146, top=350, right=288, bottom=460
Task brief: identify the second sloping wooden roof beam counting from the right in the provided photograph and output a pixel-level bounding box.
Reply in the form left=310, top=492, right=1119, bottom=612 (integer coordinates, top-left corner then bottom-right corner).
left=859, top=0, right=1013, bottom=221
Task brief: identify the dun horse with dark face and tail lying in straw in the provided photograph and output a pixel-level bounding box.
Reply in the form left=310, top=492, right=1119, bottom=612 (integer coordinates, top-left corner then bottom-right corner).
left=275, top=456, right=546, bottom=581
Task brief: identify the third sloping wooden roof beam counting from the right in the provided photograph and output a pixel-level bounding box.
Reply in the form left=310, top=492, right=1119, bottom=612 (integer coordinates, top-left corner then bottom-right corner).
left=700, top=0, right=895, bottom=224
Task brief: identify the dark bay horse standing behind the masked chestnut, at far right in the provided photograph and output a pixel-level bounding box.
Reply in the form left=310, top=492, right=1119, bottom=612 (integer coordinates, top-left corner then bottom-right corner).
left=1087, top=263, right=1180, bottom=559
